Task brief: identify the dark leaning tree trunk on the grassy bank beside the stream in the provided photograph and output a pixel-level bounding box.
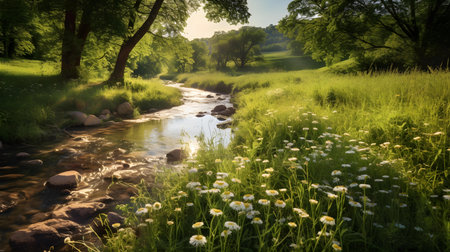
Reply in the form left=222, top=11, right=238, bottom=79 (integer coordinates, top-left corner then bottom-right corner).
left=108, top=0, right=164, bottom=83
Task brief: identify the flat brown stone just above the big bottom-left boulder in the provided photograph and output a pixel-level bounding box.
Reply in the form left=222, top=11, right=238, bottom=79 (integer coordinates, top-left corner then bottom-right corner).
left=52, top=202, right=105, bottom=224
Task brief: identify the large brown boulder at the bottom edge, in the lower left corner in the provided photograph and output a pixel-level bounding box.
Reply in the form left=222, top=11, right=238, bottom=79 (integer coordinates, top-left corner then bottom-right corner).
left=9, top=219, right=82, bottom=252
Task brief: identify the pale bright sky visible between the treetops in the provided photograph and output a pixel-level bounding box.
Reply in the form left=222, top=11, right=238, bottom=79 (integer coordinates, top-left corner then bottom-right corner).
left=183, top=0, right=291, bottom=40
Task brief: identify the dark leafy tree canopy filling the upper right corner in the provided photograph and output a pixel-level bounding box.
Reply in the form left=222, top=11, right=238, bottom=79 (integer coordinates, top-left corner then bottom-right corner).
left=279, top=0, right=450, bottom=66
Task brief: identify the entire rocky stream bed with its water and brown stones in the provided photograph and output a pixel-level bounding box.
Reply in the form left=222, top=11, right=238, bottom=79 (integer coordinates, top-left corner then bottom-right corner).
left=0, top=84, right=235, bottom=251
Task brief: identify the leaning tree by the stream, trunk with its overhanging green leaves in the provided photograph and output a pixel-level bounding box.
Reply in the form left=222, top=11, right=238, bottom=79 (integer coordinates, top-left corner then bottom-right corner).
left=108, top=0, right=250, bottom=83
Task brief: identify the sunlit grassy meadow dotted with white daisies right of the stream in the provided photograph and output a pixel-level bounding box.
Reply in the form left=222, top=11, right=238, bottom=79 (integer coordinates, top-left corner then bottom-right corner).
left=67, top=53, right=450, bottom=251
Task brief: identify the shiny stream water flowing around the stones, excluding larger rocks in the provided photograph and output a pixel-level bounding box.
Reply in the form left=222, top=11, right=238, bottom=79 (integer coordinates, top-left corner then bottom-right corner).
left=0, top=84, right=232, bottom=251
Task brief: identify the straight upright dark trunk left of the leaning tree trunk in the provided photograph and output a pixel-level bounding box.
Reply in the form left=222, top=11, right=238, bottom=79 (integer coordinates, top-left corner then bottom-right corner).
left=61, top=0, right=79, bottom=79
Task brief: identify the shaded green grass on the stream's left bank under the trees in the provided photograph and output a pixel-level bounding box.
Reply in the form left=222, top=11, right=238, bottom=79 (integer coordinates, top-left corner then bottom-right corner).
left=0, top=57, right=181, bottom=143
